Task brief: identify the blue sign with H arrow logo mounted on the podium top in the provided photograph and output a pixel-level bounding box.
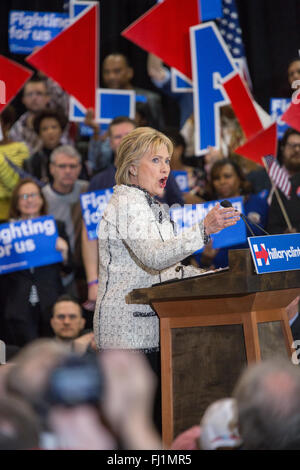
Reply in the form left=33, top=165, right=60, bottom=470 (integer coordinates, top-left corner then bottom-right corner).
left=248, top=233, right=300, bottom=274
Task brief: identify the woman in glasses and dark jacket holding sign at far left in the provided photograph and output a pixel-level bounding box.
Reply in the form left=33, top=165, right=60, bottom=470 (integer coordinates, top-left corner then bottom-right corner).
left=1, top=179, right=71, bottom=347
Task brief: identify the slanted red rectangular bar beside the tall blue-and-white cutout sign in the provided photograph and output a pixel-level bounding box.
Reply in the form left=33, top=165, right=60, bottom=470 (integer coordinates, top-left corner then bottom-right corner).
left=222, top=73, right=263, bottom=139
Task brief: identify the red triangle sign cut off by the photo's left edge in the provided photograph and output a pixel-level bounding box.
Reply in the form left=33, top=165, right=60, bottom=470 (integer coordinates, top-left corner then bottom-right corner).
left=0, top=55, right=33, bottom=113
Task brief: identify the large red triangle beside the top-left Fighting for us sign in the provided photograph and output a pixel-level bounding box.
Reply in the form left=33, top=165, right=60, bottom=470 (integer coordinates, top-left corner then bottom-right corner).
left=26, top=5, right=99, bottom=109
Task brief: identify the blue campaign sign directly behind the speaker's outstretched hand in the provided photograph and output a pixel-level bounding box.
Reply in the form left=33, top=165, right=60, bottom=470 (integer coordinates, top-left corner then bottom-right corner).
left=170, top=197, right=247, bottom=253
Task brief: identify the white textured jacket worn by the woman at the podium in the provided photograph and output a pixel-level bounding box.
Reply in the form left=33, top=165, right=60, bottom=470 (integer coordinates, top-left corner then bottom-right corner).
left=94, top=185, right=207, bottom=352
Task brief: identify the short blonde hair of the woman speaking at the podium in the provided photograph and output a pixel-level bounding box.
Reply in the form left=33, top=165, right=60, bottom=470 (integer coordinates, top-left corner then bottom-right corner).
left=115, top=127, right=173, bottom=184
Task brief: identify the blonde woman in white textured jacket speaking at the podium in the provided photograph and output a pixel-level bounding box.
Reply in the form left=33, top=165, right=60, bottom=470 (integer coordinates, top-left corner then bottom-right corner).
left=94, top=127, right=239, bottom=366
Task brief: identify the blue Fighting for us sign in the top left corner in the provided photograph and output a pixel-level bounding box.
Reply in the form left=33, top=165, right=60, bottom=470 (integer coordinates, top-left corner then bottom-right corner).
left=8, top=10, right=70, bottom=54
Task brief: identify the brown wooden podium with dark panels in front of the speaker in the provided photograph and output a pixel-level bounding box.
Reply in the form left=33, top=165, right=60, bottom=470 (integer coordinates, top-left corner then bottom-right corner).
left=127, top=249, right=300, bottom=446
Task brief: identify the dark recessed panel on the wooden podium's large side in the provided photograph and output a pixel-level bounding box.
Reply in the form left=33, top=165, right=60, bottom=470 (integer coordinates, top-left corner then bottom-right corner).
left=171, top=325, right=247, bottom=437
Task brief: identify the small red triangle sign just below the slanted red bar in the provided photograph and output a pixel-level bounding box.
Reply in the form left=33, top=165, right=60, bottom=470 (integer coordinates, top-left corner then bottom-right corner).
left=234, top=122, right=277, bottom=165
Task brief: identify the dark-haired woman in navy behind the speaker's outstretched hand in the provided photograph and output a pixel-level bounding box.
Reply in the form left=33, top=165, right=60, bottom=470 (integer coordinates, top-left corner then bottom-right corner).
left=195, top=158, right=268, bottom=268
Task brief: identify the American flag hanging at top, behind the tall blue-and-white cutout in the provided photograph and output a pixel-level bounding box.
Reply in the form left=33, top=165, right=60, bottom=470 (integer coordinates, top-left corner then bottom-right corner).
left=216, top=0, right=251, bottom=88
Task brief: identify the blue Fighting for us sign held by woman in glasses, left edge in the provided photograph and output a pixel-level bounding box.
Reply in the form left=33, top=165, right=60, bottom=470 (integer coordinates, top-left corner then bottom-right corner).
left=0, top=216, right=63, bottom=274
